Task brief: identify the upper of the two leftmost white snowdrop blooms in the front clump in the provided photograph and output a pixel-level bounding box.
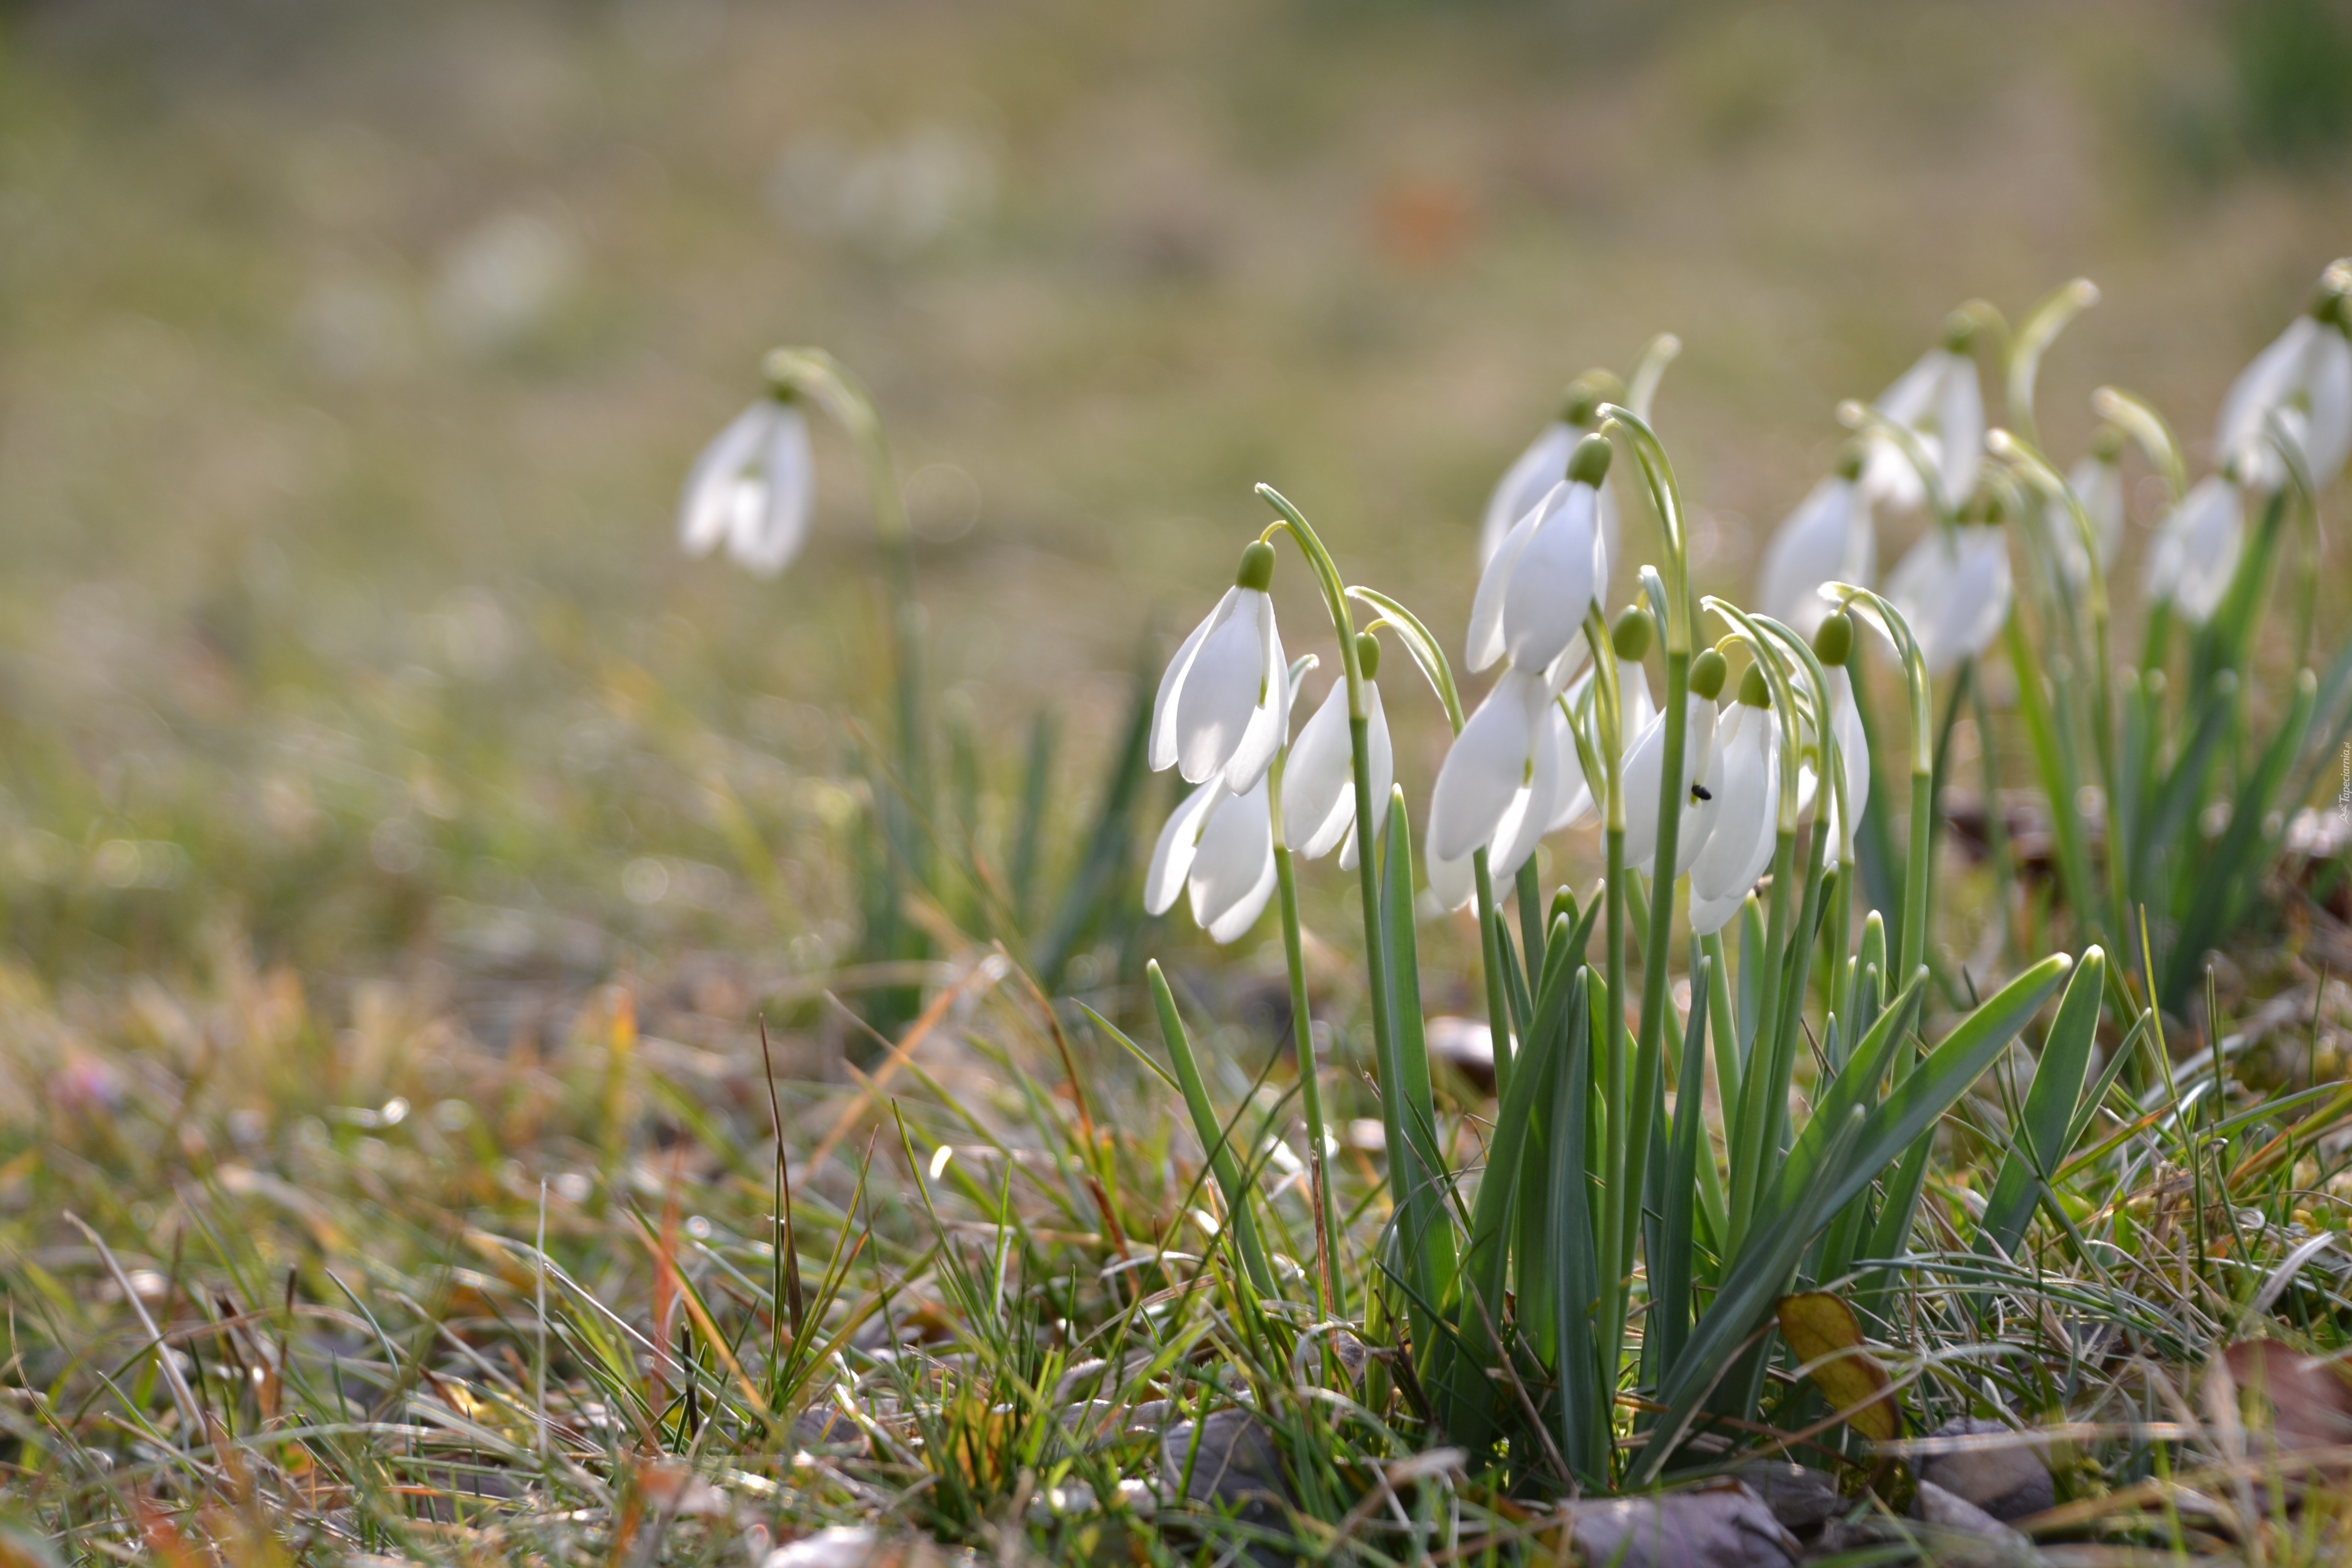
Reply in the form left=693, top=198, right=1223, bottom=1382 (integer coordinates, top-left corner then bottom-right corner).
left=1150, top=538, right=1291, bottom=795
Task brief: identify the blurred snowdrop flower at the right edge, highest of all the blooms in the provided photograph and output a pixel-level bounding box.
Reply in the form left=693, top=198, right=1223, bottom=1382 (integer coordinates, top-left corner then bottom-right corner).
left=2213, top=277, right=2352, bottom=494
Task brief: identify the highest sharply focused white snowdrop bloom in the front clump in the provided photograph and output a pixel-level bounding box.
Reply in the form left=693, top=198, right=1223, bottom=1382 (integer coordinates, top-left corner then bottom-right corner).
left=1467, top=435, right=1609, bottom=672
